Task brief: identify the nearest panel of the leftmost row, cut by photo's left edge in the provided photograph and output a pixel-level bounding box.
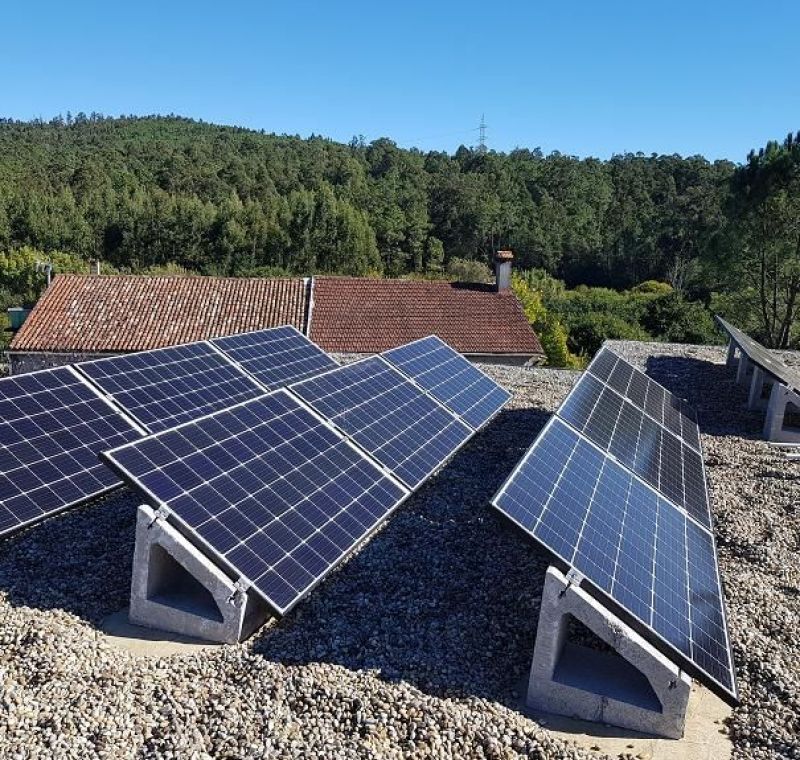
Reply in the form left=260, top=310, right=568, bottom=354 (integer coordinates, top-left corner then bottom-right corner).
left=0, top=367, right=141, bottom=534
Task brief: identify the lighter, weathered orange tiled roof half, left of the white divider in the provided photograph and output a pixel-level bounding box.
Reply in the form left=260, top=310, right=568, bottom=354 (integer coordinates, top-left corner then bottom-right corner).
left=9, top=274, right=308, bottom=352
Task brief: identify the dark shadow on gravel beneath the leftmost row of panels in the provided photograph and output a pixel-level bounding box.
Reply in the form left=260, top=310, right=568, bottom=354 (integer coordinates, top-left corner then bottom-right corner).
left=0, top=488, right=142, bottom=625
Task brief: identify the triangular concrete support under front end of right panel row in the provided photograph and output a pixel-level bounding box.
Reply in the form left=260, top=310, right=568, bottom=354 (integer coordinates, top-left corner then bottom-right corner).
left=527, top=567, right=691, bottom=739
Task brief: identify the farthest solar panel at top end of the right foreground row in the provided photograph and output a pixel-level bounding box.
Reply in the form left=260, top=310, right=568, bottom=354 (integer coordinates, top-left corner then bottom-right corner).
left=587, top=347, right=700, bottom=451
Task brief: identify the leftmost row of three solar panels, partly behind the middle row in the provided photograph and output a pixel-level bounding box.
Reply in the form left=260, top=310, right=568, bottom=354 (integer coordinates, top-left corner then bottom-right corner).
left=0, top=327, right=338, bottom=535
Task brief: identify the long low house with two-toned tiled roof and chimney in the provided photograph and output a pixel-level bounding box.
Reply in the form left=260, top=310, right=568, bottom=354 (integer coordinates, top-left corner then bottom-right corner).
left=8, top=252, right=543, bottom=374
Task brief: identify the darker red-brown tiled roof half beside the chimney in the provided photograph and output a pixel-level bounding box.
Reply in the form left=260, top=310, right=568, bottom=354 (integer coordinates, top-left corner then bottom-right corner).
left=310, top=277, right=543, bottom=356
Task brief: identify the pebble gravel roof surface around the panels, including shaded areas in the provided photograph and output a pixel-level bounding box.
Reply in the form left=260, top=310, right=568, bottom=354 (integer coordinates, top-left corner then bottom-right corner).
left=0, top=343, right=800, bottom=758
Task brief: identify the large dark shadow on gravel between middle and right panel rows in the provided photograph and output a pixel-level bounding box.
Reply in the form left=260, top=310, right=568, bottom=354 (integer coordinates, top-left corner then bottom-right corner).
left=253, top=409, right=550, bottom=704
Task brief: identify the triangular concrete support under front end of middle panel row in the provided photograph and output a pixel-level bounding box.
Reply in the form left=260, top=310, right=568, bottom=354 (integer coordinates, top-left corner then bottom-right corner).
left=129, top=505, right=269, bottom=644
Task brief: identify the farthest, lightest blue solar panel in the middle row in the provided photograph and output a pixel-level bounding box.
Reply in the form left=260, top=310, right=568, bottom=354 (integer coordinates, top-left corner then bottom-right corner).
left=382, top=335, right=511, bottom=430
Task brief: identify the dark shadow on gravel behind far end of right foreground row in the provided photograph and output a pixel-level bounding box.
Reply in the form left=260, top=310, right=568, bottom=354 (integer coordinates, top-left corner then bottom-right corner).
left=646, top=355, right=764, bottom=437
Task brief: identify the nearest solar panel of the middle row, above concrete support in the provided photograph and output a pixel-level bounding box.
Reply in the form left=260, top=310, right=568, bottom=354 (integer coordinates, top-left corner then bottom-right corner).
left=103, top=390, right=408, bottom=614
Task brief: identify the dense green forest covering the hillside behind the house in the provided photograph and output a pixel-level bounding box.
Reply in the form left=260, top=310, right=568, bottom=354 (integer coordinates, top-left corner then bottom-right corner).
left=0, top=114, right=800, bottom=354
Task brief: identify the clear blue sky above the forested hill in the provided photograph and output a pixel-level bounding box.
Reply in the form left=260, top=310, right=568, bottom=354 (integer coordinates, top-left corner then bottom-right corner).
left=0, top=0, right=800, bottom=161
